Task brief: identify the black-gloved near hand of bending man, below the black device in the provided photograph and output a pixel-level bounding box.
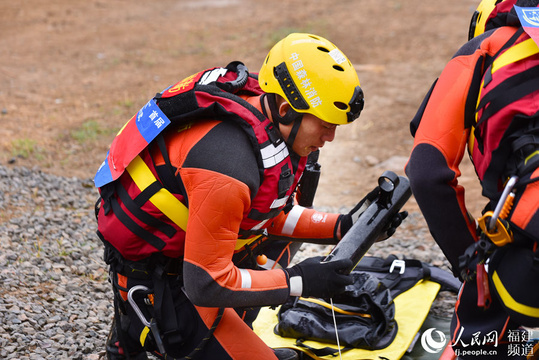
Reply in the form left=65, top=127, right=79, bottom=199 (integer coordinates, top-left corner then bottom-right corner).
left=286, top=256, right=354, bottom=298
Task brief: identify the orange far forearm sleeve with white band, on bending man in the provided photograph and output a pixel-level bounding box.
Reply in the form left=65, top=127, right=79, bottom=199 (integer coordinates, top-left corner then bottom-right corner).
left=268, top=205, right=339, bottom=244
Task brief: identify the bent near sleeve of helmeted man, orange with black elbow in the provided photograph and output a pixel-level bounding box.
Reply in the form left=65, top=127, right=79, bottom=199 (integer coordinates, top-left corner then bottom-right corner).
left=180, top=168, right=289, bottom=307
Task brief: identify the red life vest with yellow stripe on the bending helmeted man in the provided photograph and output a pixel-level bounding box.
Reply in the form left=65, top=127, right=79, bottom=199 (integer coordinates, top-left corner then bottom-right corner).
left=96, top=63, right=307, bottom=261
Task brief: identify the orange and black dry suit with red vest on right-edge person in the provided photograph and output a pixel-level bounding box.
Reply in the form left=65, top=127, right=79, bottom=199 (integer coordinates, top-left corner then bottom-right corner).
left=406, top=20, right=539, bottom=356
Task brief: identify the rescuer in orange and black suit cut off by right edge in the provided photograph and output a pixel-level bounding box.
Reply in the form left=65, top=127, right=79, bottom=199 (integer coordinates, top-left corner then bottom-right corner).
left=406, top=0, right=539, bottom=359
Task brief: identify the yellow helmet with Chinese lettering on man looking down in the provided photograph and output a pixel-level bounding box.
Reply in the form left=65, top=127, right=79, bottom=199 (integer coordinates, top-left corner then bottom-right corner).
left=258, top=33, right=364, bottom=125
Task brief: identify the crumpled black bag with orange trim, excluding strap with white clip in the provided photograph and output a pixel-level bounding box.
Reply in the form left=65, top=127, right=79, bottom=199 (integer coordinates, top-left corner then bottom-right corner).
left=274, top=271, right=397, bottom=350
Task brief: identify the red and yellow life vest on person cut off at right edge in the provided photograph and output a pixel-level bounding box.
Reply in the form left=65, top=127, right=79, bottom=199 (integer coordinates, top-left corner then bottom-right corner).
left=466, top=28, right=539, bottom=199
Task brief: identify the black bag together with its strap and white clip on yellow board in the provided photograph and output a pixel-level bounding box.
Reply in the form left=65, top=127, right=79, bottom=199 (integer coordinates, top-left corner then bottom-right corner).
left=274, top=255, right=461, bottom=356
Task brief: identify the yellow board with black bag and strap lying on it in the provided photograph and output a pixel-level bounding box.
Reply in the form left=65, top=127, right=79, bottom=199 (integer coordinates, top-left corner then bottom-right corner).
left=253, top=255, right=460, bottom=360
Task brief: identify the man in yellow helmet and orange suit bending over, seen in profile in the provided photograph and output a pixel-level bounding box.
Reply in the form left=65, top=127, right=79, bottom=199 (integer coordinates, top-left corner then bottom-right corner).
left=95, top=33, right=398, bottom=360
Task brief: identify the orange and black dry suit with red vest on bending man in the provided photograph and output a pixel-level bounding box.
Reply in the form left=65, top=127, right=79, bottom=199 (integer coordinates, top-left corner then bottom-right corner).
left=96, top=66, right=339, bottom=359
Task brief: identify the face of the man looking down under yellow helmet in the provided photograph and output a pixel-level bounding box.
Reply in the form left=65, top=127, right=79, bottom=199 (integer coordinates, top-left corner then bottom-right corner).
left=281, top=114, right=337, bottom=156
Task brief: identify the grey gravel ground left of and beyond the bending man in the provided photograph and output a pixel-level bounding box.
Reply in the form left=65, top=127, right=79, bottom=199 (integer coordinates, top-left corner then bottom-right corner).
left=0, top=166, right=455, bottom=359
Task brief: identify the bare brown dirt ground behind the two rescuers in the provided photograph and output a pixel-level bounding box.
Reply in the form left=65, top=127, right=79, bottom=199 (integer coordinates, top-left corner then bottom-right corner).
left=0, top=0, right=488, bottom=214
